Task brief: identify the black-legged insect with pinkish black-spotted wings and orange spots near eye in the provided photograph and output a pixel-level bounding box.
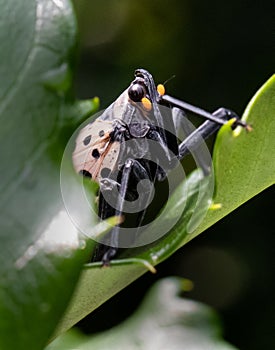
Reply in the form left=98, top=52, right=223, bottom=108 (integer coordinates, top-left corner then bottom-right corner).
left=73, top=69, right=249, bottom=265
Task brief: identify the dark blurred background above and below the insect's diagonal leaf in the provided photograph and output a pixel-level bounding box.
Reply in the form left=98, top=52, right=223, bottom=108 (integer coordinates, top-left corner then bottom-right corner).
left=72, top=0, right=275, bottom=350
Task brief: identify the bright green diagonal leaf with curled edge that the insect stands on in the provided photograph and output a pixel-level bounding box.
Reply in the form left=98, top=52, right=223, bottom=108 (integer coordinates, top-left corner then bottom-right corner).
left=57, top=77, right=275, bottom=334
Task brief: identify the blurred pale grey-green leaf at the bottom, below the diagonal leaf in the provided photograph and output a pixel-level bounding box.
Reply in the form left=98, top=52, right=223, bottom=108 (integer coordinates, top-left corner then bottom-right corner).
left=47, top=278, right=236, bottom=350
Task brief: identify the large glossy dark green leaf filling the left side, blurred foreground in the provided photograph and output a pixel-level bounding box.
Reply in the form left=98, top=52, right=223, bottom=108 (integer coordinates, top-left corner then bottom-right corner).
left=0, top=0, right=98, bottom=350
